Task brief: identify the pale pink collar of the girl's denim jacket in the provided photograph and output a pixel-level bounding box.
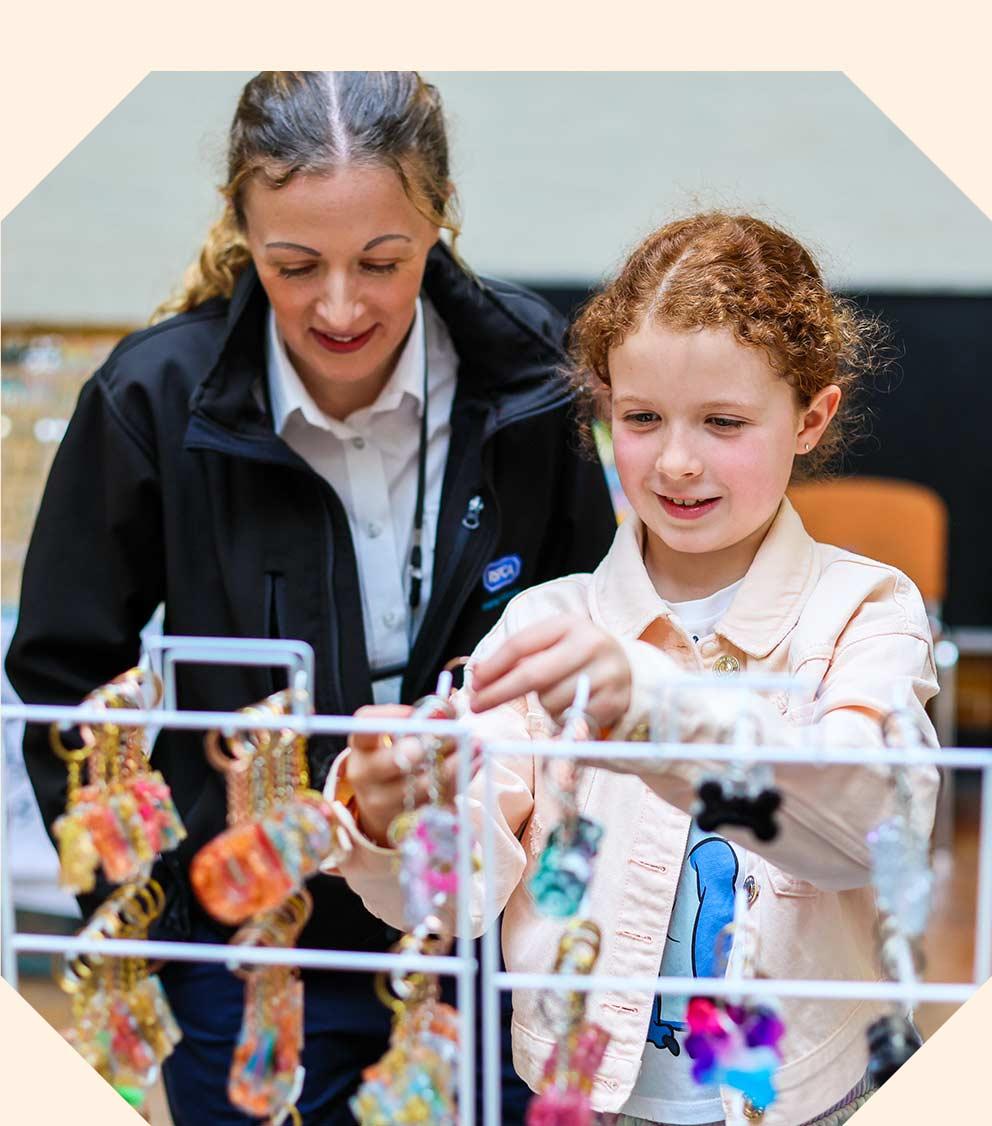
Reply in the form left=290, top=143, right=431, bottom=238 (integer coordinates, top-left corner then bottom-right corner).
left=592, top=498, right=817, bottom=659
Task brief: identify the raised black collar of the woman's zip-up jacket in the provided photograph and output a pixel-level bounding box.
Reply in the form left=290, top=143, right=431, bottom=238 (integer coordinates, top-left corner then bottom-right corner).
left=190, top=242, right=568, bottom=434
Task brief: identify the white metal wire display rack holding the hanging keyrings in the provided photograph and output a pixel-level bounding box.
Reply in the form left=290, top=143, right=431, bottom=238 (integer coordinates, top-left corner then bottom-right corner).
left=0, top=637, right=992, bottom=1126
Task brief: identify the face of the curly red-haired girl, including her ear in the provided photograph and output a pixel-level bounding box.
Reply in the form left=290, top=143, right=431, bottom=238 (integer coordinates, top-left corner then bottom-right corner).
left=609, top=322, right=840, bottom=599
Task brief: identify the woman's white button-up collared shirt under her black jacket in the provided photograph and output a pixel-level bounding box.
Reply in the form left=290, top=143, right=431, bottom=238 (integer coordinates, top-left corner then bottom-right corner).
left=267, top=298, right=458, bottom=704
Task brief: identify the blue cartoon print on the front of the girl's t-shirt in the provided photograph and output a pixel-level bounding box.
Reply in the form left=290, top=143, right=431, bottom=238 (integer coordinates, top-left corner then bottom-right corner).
left=647, top=822, right=739, bottom=1056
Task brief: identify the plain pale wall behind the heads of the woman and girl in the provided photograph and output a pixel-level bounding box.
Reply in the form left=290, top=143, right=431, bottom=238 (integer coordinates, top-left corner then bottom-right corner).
left=2, top=72, right=992, bottom=323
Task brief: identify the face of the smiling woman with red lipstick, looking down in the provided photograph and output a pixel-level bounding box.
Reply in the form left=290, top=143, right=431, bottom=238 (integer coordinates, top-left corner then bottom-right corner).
left=244, top=166, right=438, bottom=418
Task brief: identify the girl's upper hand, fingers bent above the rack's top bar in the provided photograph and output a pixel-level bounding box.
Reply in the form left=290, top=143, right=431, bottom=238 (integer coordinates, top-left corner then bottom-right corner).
left=471, top=614, right=631, bottom=727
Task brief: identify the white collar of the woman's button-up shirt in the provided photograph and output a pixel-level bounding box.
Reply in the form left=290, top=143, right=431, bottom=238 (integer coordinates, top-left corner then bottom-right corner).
left=266, top=297, right=424, bottom=438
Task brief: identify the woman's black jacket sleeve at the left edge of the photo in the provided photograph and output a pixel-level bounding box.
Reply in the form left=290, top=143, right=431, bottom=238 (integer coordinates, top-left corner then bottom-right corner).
left=6, top=374, right=163, bottom=910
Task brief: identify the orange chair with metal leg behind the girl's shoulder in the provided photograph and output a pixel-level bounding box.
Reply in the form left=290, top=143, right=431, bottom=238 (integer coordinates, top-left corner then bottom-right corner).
left=788, top=476, right=958, bottom=851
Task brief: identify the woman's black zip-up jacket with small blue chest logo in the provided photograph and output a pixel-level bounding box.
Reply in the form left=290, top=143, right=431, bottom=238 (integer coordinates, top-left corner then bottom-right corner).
left=7, top=247, right=615, bottom=949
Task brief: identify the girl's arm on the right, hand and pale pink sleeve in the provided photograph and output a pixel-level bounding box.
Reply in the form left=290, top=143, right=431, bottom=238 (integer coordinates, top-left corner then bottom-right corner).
left=473, top=605, right=938, bottom=891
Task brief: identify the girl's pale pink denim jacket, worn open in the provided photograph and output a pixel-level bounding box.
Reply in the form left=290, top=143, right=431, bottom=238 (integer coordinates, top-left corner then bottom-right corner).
left=325, top=500, right=937, bottom=1126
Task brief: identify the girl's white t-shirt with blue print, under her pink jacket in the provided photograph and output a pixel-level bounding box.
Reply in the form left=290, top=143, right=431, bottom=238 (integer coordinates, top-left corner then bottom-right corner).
left=623, top=580, right=743, bottom=1124
